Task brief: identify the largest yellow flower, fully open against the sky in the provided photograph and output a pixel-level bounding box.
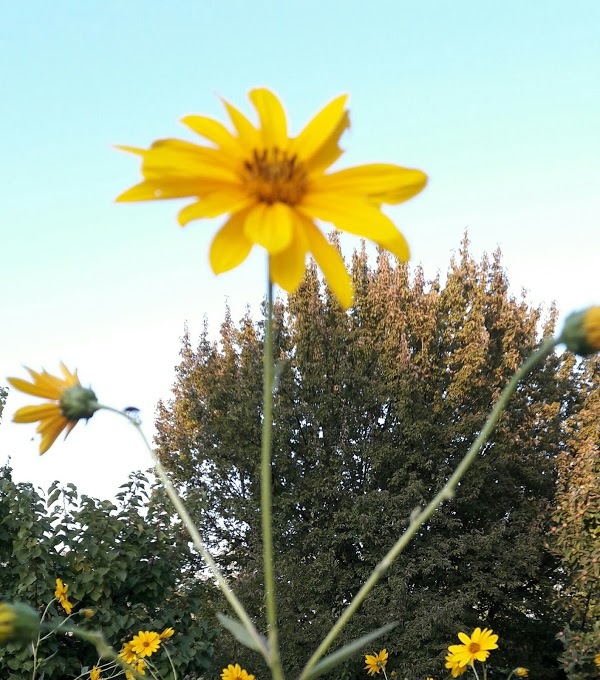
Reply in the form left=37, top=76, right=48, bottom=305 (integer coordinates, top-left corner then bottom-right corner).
left=117, top=88, right=427, bottom=307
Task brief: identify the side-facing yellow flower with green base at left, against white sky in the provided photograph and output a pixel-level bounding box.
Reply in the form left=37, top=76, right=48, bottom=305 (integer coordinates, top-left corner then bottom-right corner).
left=8, top=363, right=100, bottom=454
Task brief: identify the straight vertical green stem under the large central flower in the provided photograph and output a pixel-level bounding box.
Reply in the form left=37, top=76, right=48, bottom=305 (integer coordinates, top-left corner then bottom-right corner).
left=260, top=277, right=283, bottom=680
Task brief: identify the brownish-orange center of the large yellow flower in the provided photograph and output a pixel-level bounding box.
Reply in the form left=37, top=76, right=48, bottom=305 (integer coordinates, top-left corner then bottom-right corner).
left=243, top=146, right=306, bottom=205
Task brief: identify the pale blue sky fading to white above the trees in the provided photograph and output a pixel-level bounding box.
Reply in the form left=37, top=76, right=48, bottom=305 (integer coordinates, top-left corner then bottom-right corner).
left=0, top=0, right=600, bottom=497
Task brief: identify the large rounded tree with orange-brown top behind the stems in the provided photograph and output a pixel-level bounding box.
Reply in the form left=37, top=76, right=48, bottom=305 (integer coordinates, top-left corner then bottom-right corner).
left=157, top=237, right=585, bottom=680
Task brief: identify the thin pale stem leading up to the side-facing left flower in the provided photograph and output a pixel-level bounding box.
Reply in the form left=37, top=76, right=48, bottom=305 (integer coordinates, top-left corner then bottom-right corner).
left=100, top=404, right=270, bottom=663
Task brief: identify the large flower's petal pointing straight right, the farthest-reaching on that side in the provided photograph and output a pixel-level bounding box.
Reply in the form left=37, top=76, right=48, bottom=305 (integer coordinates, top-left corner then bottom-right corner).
left=309, top=163, right=427, bottom=203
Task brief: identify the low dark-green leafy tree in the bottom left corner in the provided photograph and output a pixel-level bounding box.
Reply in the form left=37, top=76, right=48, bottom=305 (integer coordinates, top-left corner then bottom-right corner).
left=0, top=466, right=214, bottom=680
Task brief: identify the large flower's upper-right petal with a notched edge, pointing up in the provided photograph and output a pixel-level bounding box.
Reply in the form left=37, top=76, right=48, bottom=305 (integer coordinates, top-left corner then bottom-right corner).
left=290, top=95, right=350, bottom=171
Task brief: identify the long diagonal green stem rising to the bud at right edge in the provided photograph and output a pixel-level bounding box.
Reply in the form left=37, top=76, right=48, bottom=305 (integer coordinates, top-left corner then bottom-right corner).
left=298, top=338, right=561, bottom=680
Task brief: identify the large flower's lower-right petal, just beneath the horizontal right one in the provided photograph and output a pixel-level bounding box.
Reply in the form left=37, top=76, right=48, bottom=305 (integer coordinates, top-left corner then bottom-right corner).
left=296, top=197, right=410, bottom=262
